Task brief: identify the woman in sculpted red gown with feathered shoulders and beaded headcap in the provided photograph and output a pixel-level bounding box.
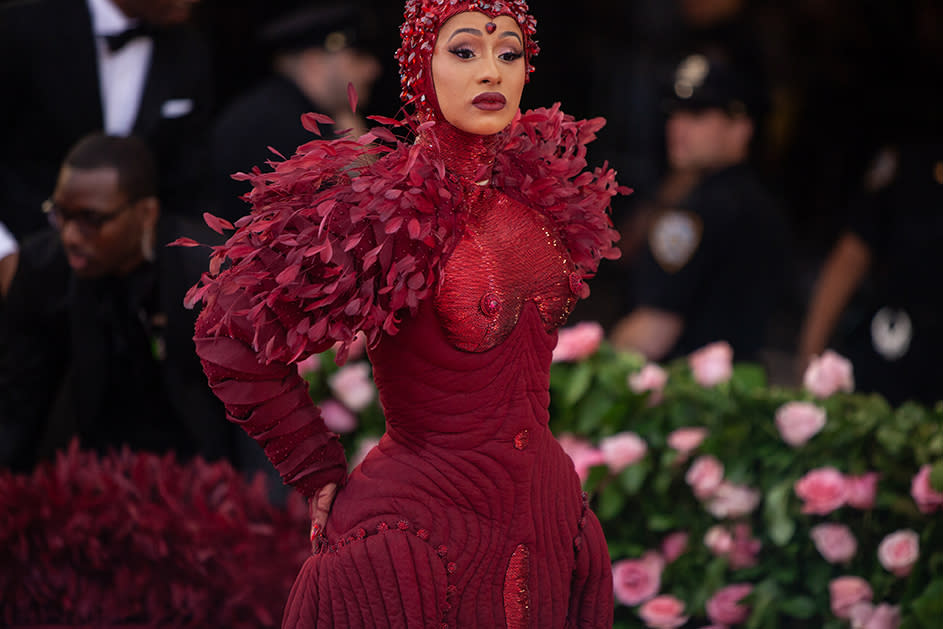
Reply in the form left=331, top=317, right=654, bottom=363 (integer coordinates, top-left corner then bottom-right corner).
left=189, top=0, right=620, bottom=628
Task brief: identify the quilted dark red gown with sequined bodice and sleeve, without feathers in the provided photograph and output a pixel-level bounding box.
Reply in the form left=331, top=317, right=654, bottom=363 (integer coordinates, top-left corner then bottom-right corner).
left=196, top=115, right=612, bottom=629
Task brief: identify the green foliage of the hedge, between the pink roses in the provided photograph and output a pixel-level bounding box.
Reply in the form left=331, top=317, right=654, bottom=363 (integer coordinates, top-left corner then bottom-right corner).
left=550, top=345, right=943, bottom=629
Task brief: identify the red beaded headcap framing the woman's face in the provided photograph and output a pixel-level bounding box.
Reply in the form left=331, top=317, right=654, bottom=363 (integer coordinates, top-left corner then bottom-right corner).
left=396, top=0, right=540, bottom=109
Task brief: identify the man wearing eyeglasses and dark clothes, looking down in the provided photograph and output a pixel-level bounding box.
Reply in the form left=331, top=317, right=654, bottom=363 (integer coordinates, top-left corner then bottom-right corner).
left=0, top=134, right=251, bottom=470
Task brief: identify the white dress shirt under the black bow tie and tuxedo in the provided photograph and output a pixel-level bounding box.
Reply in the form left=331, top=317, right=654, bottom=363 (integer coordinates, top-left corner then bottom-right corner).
left=86, top=0, right=154, bottom=135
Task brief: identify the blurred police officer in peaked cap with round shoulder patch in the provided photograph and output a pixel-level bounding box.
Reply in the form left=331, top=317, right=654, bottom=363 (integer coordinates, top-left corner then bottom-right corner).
left=611, top=53, right=788, bottom=360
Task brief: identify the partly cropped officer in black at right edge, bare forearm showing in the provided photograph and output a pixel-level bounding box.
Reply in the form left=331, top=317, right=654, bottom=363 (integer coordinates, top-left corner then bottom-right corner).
left=799, top=143, right=943, bottom=404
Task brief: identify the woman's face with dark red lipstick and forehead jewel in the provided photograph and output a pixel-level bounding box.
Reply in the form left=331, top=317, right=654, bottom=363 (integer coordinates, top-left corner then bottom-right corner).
left=432, top=11, right=527, bottom=135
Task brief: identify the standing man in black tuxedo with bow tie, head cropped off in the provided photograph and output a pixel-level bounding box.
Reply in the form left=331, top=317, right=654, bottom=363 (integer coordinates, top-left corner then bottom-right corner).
left=0, top=0, right=212, bottom=239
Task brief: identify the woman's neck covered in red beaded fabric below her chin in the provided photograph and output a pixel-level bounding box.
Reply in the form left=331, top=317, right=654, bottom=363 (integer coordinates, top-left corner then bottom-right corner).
left=419, top=120, right=507, bottom=183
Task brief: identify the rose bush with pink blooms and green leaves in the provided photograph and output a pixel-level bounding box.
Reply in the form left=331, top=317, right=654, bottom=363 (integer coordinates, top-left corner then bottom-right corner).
left=551, top=343, right=943, bottom=629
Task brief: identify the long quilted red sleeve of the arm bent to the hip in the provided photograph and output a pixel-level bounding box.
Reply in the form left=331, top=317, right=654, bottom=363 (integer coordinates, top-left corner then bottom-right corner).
left=194, top=292, right=347, bottom=496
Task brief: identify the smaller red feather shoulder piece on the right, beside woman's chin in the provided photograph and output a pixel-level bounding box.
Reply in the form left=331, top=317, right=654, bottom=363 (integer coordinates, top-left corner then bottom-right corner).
left=494, top=103, right=631, bottom=297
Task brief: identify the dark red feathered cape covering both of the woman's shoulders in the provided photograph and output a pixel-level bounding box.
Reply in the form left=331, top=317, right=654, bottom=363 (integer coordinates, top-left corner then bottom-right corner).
left=181, top=104, right=628, bottom=363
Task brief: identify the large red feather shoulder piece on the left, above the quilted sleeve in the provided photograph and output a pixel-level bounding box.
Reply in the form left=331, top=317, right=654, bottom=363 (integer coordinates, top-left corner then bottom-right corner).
left=187, top=120, right=462, bottom=363
